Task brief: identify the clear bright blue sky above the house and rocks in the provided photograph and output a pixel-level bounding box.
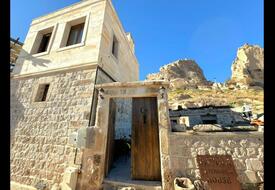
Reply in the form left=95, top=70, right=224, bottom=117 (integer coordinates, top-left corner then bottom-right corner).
left=11, top=0, right=263, bottom=82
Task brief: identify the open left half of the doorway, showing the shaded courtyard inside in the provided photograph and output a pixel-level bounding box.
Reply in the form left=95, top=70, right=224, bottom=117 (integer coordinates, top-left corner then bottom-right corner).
left=105, top=98, right=132, bottom=180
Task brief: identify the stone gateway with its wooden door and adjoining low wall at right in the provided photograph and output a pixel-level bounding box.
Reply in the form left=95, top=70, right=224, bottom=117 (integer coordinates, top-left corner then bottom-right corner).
left=75, top=81, right=263, bottom=190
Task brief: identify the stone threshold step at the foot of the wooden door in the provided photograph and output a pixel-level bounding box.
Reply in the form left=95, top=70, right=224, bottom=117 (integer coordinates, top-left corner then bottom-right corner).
left=103, top=179, right=162, bottom=190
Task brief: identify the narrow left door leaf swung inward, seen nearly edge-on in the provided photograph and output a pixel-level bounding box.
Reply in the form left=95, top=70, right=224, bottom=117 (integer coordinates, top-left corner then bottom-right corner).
left=105, top=99, right=116, bottom=176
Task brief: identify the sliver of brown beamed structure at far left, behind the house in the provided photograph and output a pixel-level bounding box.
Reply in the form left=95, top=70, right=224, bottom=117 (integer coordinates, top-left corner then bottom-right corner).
left=10, top=38, right=23, bottom=72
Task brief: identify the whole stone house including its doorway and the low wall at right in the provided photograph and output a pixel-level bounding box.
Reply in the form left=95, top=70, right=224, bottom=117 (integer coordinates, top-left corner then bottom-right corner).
left=10, top=0, right=263, bottom=190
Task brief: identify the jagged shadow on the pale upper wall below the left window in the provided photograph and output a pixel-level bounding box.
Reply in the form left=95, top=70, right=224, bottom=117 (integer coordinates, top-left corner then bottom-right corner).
left=14, top=49, right=51, bottom=74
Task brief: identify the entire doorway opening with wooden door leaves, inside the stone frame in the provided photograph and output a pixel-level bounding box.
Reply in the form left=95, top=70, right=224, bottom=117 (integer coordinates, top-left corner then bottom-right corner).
left=105, top=97, right=161, bottom=181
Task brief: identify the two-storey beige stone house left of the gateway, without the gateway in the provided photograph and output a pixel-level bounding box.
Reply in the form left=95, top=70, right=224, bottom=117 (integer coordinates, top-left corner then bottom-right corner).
left=10, top=0, right=139, bottom=189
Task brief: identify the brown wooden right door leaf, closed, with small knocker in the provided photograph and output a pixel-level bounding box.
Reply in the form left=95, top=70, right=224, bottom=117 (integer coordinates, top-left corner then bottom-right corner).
left=131, top=97, right=161, bottom=180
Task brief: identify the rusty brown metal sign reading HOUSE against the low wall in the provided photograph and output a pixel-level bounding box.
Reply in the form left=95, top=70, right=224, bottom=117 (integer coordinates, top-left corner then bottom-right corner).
left=197, top=155, right=241, bottom=190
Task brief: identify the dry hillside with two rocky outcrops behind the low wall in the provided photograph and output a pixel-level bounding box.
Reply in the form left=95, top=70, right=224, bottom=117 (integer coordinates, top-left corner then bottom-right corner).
left=147, top=44, right=264, bottom=114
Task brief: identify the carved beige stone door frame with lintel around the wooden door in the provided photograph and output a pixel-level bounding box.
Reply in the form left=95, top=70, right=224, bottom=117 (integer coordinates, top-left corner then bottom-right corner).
left=94, top=81, right=173, bottom=190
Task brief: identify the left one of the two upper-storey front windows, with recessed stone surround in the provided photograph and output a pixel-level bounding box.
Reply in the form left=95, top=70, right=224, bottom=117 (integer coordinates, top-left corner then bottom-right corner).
left=31, top=27, right=53, bottom=54
